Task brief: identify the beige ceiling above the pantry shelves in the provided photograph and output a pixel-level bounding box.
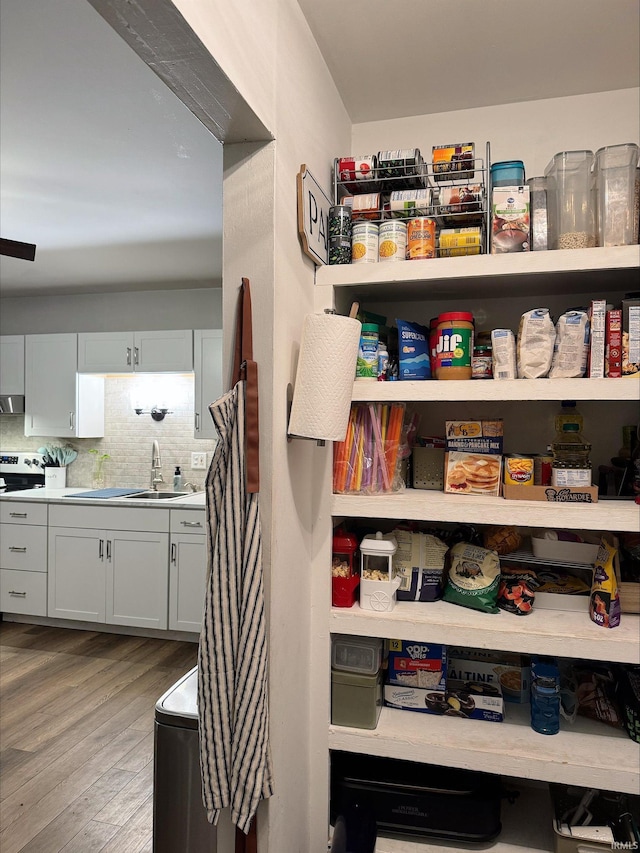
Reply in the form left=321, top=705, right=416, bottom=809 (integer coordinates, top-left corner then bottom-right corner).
left=298, top=0, right=640, bottom=123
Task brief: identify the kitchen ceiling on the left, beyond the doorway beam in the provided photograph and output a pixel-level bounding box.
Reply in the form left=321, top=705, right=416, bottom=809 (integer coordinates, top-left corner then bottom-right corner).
left=0, top=0, right=222, bottom=297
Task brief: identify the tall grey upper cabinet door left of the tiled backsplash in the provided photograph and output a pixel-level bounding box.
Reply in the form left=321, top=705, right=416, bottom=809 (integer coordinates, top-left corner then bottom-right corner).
left=24, top=334, right=78, bottom=437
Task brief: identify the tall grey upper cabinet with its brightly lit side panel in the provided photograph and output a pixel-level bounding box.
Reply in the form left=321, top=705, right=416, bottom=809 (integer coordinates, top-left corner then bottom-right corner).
left=24, top=333, right=104, bottom=438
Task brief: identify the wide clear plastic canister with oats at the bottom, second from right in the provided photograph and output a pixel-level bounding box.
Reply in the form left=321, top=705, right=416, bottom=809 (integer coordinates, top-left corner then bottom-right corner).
left=545, top=150, right=596, bottom=249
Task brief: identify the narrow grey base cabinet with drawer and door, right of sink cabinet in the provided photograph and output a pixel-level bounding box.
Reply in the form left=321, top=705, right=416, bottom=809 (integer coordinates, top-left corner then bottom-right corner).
left=169, top=510, right=207, bottom=633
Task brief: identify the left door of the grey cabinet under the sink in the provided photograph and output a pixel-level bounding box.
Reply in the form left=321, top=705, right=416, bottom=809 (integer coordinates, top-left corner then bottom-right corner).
left=47, top=527, right=106, bottom=622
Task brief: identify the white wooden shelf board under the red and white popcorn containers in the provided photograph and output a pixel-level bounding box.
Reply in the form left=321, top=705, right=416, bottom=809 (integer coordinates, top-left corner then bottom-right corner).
left=329, top=601, right=640, bottom=664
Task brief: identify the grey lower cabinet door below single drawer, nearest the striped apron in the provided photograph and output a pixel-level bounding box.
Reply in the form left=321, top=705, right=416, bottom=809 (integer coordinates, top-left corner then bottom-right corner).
left=169, top=533, right=207, bottom=632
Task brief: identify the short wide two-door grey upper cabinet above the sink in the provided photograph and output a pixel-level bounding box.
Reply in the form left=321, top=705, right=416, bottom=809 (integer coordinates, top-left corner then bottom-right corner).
left=78, top=329, right=193, bottom=373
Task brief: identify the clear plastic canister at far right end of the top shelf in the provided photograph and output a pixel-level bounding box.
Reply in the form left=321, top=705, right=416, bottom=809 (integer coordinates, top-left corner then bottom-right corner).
left=596, top=142, right=638, bottom=246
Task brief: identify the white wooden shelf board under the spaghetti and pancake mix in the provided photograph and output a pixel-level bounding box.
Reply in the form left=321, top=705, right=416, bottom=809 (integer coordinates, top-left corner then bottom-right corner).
left=331, top=490, right=640, bottom=533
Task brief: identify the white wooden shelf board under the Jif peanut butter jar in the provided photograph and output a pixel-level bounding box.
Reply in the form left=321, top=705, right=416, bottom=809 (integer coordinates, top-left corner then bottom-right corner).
left=352, top=376, right=640, bottom=403
